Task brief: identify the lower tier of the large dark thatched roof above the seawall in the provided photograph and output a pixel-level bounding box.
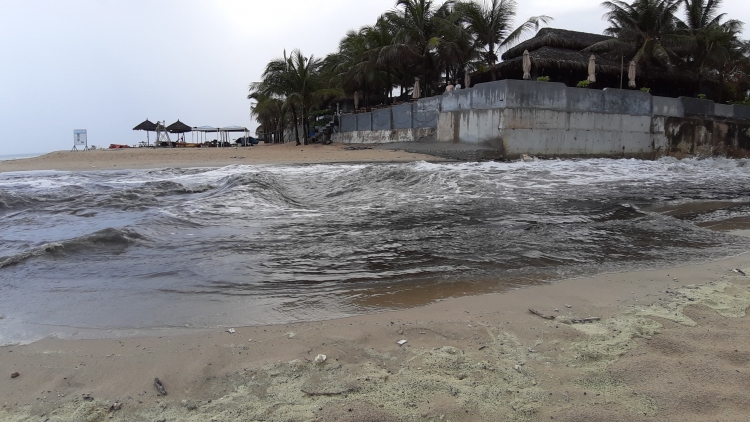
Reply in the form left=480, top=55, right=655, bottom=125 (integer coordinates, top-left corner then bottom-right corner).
left=497, top=47, right=620, bottom=74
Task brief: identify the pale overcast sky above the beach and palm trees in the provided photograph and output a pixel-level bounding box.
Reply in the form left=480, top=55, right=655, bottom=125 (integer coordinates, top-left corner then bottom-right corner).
left=0, top=0, right=750, bottom=155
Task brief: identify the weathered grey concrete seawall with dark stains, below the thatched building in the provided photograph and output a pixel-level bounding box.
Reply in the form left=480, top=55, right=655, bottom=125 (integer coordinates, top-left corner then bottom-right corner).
left=334, top=80, right=750, bottom=159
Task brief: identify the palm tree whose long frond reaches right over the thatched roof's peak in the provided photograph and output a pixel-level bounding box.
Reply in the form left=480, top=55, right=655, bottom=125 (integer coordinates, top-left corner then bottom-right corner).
left=456, top=0, right=552, bottom=81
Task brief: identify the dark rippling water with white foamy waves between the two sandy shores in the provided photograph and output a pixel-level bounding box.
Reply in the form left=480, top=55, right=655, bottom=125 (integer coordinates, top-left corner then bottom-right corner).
left=0, top=159, right=750, bottom=344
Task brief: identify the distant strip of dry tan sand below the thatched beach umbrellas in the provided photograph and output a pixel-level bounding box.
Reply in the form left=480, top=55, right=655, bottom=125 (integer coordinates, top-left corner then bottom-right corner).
left=0, top=143, right=442, bottom=172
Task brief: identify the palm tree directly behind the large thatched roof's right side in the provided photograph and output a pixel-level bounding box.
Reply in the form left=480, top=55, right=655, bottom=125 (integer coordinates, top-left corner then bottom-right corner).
left=586, top=0, right=689, bottom=72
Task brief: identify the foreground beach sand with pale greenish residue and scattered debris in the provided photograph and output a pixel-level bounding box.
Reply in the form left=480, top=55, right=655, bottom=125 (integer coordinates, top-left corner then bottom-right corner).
left=0, top=254, right=750, bottom=421
